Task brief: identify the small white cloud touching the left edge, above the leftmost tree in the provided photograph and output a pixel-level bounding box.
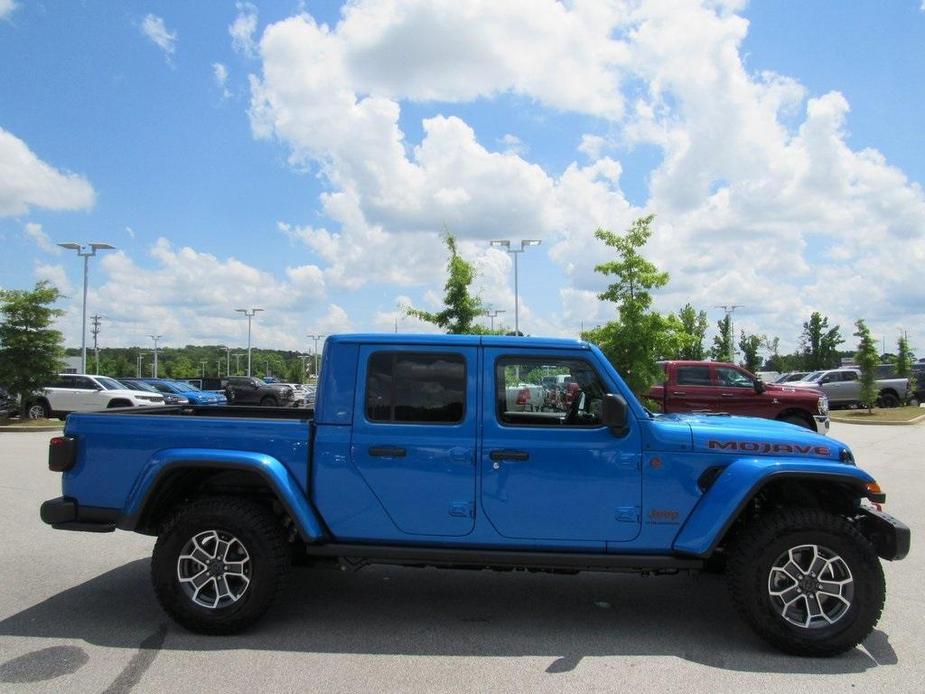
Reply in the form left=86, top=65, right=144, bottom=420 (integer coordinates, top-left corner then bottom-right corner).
left=0, top=128, right=96, bottom=217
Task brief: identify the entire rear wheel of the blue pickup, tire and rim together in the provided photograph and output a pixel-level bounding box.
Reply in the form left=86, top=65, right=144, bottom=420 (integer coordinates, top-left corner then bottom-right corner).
left=151, top=497, right=290, bottom=634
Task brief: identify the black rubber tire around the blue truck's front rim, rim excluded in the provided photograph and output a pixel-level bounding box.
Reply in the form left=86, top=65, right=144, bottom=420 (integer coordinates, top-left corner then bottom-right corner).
left=728, top=509, right=886, bottom=657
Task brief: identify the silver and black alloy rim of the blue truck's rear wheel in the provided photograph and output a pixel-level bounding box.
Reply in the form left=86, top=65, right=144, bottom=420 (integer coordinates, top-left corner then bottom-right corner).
left=177, top=530, right=251, bottom=610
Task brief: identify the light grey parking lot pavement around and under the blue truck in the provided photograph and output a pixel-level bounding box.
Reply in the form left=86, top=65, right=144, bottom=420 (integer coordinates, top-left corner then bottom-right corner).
left=0, top=423, right=925, bottom=694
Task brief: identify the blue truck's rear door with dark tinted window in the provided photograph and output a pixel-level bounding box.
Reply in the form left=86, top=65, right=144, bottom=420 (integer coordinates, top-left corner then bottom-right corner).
left=350, top=345, right=479, bottom=536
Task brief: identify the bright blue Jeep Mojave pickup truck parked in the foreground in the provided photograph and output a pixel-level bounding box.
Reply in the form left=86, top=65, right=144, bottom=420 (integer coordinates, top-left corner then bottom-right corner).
left=41, top=335, right=910, bottom=656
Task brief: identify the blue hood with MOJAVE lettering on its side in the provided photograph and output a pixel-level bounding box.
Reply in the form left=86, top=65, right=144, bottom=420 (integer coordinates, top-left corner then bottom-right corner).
left=660, top=414, right=853, bottom=461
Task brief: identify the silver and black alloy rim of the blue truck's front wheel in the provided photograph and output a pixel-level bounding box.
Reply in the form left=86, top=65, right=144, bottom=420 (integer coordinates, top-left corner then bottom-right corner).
left=768, top=545, right=854, bottom=629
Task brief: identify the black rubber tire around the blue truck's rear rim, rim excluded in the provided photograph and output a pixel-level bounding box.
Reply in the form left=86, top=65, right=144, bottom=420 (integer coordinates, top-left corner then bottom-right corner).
left=151, top=497, right=291, bottom=634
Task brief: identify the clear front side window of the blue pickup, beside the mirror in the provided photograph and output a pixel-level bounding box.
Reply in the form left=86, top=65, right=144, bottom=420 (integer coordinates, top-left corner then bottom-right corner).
left=495, top=357, right=607, bottom=426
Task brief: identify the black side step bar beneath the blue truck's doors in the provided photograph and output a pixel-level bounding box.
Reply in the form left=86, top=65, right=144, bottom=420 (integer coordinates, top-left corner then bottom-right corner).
left=306, top=544, right=704, bottom=573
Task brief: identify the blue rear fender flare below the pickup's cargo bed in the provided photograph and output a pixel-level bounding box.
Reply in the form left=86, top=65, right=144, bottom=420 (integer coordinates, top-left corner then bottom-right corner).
left=119, top=448, right=326, bottom=542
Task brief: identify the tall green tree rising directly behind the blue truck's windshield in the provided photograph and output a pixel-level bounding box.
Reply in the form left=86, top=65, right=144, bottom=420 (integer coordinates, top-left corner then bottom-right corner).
left=582, top=215, right=681, bottom=395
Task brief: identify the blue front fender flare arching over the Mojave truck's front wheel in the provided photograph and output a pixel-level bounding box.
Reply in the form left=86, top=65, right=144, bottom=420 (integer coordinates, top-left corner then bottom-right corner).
left=673, top=458, right=874, bottom=557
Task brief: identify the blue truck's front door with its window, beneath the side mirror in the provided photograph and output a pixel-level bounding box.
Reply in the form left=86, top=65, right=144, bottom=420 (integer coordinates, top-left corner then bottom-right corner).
left=480, top=349, right=642, bottom=543
